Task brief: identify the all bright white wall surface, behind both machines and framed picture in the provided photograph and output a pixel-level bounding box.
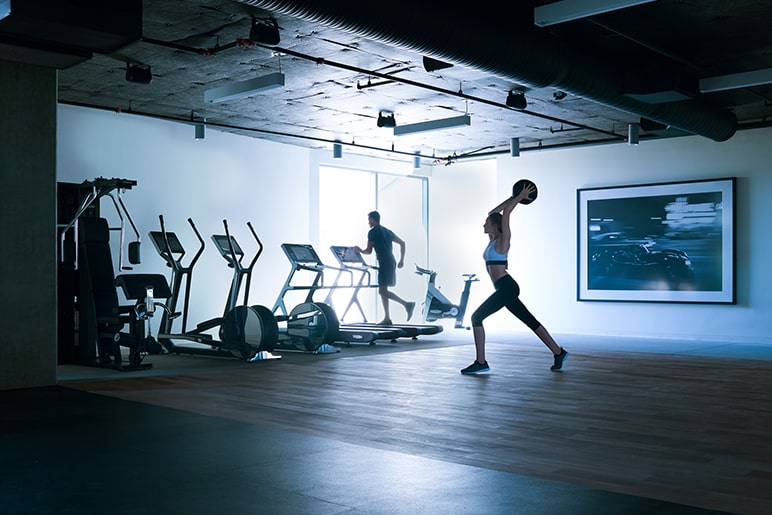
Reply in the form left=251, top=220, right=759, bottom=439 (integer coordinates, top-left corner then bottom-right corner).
left=58, top=106, right=772, bottom=343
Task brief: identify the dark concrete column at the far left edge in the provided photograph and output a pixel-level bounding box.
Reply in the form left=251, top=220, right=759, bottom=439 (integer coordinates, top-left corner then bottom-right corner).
left=0, top=61, right=57, bottom=390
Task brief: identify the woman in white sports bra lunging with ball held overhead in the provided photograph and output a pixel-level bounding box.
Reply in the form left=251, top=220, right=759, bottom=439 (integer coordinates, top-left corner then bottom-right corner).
left=461, top=183, right=568, bottom=374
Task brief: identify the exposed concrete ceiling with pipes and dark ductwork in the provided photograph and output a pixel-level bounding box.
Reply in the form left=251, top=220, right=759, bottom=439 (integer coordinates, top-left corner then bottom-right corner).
left=6, top=0, right=772, bottom=164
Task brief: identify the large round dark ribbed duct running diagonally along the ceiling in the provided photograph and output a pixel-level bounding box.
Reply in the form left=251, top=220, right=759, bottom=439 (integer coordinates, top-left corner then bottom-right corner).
left=239, top=0, right=737, bottom=141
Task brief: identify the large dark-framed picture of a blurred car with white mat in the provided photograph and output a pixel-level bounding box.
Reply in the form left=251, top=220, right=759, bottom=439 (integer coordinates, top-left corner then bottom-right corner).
left=577, top=177, right=736, bottom=304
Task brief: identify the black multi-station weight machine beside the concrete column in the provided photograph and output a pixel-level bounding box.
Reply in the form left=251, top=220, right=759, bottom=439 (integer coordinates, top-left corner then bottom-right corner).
left=57, top=177, right=155, bottom=371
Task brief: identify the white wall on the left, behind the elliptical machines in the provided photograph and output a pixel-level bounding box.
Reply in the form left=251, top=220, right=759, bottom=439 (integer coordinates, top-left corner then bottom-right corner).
left=57, top=106, right=310, bottom=330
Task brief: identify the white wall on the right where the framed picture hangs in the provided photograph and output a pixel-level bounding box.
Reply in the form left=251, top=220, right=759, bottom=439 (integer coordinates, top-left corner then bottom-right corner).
left=432, top=129, right=772, bottom=343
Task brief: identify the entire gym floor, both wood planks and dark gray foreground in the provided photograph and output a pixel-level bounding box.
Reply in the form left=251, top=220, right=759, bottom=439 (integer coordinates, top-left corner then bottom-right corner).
left=7, top=331, right=772, bottom=514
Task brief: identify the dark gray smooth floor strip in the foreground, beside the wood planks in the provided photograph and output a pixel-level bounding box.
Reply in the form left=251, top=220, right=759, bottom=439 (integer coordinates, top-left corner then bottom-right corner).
left=0, top=386, right=732, bottom=515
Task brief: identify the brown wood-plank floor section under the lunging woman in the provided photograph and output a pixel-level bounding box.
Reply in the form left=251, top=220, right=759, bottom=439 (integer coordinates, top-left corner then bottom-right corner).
left=61, top=335, right=772, bottom=514
